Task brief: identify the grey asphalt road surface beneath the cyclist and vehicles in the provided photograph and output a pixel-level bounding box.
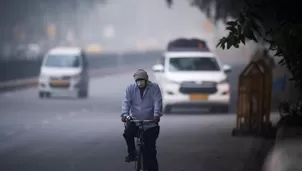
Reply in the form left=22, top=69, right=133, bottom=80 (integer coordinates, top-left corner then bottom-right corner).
left=0, top=60, right=262, bottom=171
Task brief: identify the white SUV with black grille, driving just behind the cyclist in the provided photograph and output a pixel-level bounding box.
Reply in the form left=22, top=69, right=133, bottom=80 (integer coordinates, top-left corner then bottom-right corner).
left=152, top=51, right=231, bottom=113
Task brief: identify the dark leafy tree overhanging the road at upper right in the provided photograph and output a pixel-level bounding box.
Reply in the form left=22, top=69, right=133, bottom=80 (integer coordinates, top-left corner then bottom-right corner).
left=166, top=0, right=302, bottom=96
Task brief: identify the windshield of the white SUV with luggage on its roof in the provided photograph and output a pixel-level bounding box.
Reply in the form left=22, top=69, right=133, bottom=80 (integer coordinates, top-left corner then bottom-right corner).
left=169, top=57, right=220, bottom=72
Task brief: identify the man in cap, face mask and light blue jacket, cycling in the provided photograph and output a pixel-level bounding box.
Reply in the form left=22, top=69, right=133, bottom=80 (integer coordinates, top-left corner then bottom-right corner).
left=121, top=69, right=162, bottom=171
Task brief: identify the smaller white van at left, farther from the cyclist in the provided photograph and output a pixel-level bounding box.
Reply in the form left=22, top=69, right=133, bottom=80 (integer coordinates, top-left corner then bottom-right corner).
left=38, top=47, right=89, bottom=98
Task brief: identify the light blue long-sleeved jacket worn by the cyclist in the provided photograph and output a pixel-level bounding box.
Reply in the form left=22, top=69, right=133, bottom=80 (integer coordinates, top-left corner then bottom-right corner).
left=121, top=81, right=162, bottom=126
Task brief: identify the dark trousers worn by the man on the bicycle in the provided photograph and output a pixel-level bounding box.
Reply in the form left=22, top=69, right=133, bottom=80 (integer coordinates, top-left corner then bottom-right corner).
left=123, top=122, right=160, bottom=171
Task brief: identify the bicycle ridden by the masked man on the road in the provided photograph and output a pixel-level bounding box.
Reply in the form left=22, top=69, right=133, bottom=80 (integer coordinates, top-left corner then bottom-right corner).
left=127, top=116, right=155, bottom=171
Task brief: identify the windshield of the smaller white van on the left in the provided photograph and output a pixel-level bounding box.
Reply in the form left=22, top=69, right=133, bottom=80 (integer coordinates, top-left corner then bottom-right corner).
left=44, top=55, right=80, bottom=68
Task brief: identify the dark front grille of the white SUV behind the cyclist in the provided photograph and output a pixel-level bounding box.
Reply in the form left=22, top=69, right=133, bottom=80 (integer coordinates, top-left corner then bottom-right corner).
left=179, top=81, right=217, bottom=94
